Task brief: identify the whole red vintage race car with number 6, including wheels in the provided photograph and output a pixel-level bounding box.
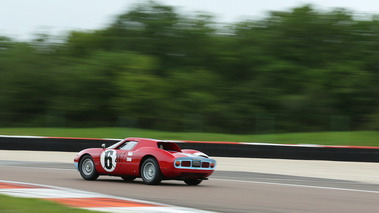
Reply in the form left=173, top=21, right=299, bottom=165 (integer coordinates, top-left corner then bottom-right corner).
left=74, top=138, right=216, bottom=185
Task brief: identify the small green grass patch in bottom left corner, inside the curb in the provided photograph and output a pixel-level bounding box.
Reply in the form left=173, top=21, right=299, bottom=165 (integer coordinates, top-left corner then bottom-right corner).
left=0, top=194, right=101, bottom=213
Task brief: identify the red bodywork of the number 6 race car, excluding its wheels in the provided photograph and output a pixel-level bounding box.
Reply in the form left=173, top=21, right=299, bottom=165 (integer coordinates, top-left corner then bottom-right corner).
left=74, top=138, right=216, bottom=179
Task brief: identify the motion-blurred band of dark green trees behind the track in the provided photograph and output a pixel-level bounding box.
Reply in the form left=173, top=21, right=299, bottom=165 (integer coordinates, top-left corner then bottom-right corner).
left=0, top=2, right=379, bottom=133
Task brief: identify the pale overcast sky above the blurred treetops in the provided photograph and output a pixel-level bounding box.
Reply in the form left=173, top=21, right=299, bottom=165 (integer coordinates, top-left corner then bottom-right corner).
left=0, top=0, right=379, bottom=40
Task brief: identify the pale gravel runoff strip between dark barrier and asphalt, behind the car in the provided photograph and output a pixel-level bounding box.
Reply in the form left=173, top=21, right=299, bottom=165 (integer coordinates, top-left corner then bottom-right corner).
left=0, top=150, right=379, bottom=184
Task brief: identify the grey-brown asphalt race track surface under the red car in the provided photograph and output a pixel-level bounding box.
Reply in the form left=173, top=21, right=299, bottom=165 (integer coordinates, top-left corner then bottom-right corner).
left=0, top=158, right=379, bottom=213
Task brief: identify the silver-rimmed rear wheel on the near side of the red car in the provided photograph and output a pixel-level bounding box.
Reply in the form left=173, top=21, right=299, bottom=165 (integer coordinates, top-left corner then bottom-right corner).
left=140, top=157, right=163, bottom=185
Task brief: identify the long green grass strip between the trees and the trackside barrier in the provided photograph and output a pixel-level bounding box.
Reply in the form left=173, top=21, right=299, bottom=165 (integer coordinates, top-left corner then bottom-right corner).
left=0, top=128, right=379, bottom=147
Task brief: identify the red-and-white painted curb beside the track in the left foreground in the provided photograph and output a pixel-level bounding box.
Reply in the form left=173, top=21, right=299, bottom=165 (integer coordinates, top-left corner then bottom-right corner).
left=0, top=180, right=218, bottom=213
